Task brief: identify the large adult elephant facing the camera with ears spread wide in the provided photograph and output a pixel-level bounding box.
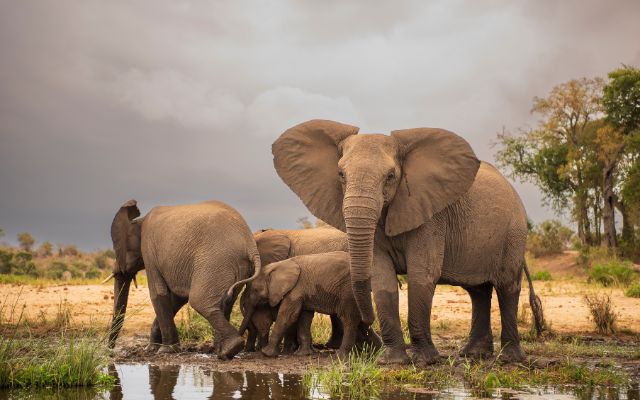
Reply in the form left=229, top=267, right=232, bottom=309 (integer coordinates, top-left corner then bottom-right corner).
left=272, top=120, right=544, bottom=365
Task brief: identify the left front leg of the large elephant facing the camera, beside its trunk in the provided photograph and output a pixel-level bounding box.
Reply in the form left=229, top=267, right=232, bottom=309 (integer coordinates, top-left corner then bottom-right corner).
left=371, top=252, right=409, bottom=364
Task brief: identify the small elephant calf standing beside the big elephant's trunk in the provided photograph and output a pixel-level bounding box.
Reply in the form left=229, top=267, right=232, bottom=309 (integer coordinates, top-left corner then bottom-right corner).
left=235, top=251, right=380, bottom=357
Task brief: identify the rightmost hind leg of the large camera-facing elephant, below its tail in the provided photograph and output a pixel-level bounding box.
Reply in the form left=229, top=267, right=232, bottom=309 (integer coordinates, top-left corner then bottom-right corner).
left=496, top=284, right=525, bottom=362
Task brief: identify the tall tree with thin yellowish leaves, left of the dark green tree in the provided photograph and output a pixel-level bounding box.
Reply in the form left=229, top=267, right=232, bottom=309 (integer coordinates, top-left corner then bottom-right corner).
left=496, top=78, right=604, bottom=244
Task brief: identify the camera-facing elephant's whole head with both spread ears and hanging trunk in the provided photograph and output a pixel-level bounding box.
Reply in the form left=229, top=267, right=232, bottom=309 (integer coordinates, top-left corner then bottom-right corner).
left=272, top=120, right=480, bottom=324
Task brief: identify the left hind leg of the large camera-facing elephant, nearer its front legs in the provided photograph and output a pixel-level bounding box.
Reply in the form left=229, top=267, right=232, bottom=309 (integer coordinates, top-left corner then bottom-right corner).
left=460, top=283, right=493, bottom=358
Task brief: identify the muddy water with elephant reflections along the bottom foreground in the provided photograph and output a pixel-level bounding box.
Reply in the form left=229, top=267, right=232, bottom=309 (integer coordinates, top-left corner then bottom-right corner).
left=0, top=364, right=640, bottom=400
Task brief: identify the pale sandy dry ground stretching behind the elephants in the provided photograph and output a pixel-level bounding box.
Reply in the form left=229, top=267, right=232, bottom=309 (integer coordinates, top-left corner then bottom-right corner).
left=0, top=252, right=640, bottom=338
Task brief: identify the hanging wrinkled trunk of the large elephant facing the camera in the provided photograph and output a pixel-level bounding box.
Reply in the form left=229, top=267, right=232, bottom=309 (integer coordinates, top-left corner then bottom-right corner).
left=343, top=196, right=379, bottom=325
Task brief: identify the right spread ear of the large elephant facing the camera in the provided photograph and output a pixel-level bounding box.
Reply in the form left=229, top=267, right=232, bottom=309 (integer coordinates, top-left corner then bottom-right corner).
left=385, top=128, right=480, bottom=236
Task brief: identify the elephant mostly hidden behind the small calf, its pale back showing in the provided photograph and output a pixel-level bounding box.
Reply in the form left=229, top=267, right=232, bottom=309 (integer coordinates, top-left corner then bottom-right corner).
left=240, top=226, right=347, bottom=352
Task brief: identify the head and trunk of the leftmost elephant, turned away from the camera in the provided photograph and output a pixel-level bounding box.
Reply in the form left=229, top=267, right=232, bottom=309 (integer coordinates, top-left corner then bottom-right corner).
left=109, top=200, right=144, bottom=347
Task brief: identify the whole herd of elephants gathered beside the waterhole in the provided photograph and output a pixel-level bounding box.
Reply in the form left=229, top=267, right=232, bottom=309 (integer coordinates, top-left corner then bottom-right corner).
left=104, top=120, right=541, bottom=366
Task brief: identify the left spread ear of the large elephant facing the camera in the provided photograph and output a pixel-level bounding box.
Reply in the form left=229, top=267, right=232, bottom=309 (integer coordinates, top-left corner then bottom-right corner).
left=271, top=119, right=358, bottom=231
